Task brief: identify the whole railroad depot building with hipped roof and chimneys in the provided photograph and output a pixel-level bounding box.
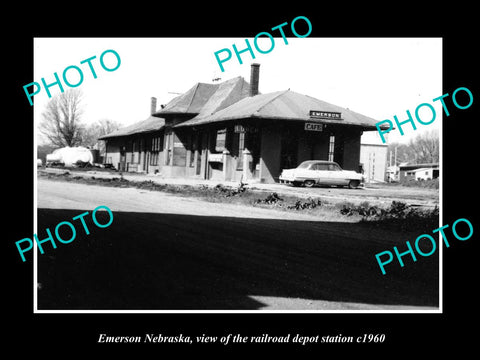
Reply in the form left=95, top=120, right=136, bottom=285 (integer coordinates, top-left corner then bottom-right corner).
left=100, top=64, right=384, bottom=183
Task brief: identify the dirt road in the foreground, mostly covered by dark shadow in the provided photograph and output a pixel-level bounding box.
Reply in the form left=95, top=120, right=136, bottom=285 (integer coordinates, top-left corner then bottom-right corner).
left=38, top=178, right=438, bottom=310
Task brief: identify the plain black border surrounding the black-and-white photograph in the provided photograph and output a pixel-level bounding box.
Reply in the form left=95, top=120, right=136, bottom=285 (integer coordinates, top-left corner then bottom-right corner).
left=2, top=2, right=480, bottom=357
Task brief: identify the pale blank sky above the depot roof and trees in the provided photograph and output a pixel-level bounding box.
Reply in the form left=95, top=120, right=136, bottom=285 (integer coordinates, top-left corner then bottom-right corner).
left=31, top=37, right=440, bottom=143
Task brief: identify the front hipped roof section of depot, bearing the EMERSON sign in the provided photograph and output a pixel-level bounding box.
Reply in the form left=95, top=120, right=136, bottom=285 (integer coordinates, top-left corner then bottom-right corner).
left=176, top=90, right=384, bottom=130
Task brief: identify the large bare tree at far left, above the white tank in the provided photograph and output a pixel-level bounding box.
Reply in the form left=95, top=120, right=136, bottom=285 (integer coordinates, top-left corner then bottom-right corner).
left=39, top=89, right=84, bottom=147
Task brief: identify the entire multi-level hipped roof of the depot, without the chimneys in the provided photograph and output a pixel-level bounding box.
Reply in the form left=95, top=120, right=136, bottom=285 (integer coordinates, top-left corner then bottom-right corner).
left=99, top=76, right=388, bottom=139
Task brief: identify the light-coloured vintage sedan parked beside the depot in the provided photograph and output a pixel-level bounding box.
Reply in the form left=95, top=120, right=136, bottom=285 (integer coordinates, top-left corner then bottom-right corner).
left=279, top=160, right=365, bottom=189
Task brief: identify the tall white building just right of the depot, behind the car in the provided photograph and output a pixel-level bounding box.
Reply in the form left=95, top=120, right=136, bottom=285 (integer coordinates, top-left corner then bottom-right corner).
left=360, top=131, right=388, bottom=183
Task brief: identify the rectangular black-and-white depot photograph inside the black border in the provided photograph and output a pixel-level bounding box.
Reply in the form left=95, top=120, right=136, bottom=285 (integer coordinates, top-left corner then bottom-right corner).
left=31, top=37, right=440, bottom=312
